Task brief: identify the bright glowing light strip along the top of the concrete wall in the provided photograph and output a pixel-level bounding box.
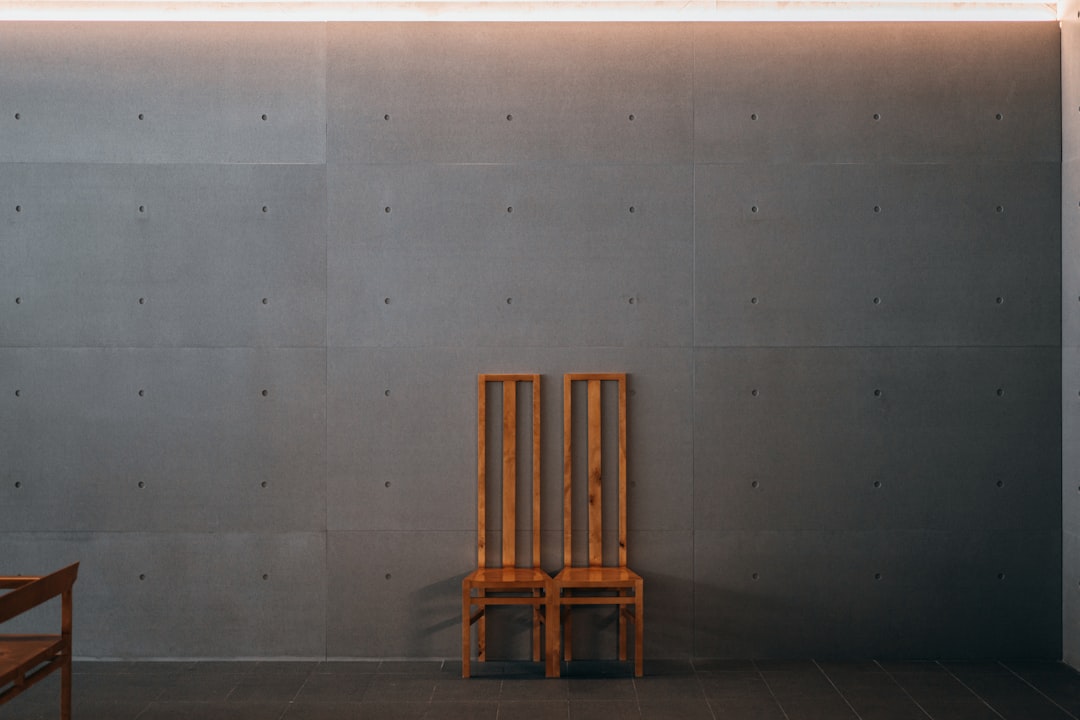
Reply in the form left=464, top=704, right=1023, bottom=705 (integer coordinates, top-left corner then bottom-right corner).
left=0, top=0, right=1059, bottom=22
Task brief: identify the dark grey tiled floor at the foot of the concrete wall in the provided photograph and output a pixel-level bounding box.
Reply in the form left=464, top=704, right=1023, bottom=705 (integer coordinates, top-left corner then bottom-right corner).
left=6, top=661, right=1080, bottom=720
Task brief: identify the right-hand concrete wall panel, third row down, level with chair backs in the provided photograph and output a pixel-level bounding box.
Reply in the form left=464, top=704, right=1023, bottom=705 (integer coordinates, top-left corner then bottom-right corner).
left=694, top=348, right=1061, bottom=532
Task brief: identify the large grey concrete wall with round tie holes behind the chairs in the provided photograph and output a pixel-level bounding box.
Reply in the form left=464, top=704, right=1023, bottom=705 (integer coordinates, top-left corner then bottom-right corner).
left=0, top=19, right=1058, bottom=658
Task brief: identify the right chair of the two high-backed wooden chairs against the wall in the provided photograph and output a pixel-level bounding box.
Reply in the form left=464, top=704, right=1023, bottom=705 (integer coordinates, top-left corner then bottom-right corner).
left=555, top=372, right=645, bottom=677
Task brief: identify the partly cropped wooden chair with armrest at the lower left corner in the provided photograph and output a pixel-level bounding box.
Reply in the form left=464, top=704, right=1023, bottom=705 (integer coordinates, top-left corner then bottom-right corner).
left=0, top=562, right=79, bottom=720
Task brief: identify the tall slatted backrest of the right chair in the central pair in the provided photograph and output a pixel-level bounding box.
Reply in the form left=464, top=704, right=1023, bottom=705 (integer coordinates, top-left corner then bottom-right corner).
left=563, top=372, right=626, bottom=567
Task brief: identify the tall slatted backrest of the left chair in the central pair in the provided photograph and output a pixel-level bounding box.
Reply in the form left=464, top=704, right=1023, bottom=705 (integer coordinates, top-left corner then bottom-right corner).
left=476, top=373, right=540, bottom=568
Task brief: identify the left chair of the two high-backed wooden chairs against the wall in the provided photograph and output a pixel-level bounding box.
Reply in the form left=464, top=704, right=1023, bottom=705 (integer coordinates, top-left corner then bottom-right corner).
left=461, top=375, right=558, bottom=678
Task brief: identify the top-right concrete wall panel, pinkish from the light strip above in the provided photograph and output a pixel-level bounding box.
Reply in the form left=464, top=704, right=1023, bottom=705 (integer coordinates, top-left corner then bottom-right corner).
left=693, top=23, right=1061, bottom=163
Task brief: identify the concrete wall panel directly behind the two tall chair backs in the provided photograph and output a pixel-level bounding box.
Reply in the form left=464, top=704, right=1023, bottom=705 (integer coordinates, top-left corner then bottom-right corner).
left=327, top=348, right=692, bottom=535
